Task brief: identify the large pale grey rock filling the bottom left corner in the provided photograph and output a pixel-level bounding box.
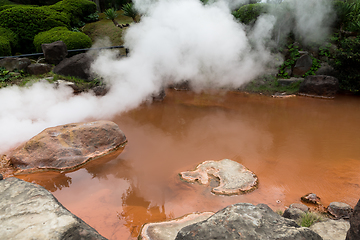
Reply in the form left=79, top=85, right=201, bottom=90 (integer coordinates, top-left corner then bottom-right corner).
left=0, top=178, right=106, bottom=240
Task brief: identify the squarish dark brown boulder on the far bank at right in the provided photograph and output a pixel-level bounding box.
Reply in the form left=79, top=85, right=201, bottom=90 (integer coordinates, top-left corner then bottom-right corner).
left=299, top=75, right=339, bottom=98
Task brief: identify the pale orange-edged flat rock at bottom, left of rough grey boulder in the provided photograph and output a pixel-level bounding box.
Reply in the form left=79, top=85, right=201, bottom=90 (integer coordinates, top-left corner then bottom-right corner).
left=138, top=212, right=214, bottom=240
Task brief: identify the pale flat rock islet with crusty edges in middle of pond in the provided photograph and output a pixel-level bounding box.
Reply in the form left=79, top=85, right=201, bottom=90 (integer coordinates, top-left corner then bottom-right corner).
left=180, top=159, right=258, bottom=195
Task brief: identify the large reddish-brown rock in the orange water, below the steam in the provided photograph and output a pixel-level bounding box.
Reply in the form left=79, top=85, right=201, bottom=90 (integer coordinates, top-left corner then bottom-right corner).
left=8, top=121, right=126, bottom=173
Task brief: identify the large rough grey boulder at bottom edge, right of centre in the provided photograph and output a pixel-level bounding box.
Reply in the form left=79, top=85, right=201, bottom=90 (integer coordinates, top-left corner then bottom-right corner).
left=175, top=203, right=322, bottom=240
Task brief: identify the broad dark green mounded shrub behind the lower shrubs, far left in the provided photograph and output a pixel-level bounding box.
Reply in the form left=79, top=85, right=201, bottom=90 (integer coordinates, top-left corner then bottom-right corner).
left=0, top=6, right=69, bottom=52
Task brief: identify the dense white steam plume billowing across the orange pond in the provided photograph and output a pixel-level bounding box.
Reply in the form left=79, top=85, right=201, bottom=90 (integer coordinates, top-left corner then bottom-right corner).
left=0, top=0, right=332, bottom=152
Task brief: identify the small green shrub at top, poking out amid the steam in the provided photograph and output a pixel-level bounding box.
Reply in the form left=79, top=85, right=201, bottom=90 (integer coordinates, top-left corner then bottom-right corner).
left=233, top=3, right=268, bottom=24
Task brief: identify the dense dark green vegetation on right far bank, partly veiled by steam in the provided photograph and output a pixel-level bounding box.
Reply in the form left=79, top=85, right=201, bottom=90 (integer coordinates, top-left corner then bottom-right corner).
left=233, top=0, right=360, bottom=93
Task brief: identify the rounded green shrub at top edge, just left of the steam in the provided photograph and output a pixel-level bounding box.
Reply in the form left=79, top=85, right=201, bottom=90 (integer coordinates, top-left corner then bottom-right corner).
left=49, top=0, right=96, bottom=26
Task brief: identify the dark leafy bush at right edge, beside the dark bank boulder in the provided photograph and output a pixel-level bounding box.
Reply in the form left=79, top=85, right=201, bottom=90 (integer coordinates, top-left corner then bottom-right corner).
left=334, top=37, right=360, bottom=93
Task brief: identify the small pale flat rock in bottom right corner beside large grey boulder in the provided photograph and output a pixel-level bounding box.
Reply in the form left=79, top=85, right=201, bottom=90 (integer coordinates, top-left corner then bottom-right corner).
left=310, top=219, right=350, bottom=240
